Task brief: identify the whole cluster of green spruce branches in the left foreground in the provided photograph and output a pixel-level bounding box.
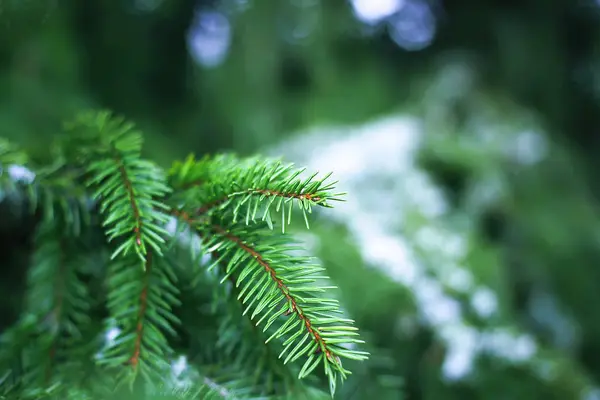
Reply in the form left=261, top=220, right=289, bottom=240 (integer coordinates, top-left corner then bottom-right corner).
left=0, top=112, right=367, bottom=400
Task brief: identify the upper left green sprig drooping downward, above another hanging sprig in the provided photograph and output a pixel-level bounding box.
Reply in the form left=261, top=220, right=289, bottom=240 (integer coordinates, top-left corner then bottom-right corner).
left=66, top=112, right=170, bottom=268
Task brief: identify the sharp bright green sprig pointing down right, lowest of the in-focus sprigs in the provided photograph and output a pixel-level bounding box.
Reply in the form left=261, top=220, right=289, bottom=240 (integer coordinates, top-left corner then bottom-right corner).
left=198, top=220, right=367, bottom=393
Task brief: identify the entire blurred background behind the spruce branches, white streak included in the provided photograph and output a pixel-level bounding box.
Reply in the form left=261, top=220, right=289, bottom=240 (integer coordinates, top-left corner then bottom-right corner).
left=0, top=0, right=600, bottom=400
